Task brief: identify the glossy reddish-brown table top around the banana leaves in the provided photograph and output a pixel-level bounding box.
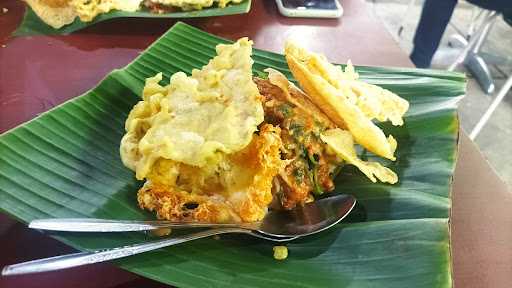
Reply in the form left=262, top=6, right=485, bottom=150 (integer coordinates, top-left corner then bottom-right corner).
left=0, top=0, right=512, bottom=287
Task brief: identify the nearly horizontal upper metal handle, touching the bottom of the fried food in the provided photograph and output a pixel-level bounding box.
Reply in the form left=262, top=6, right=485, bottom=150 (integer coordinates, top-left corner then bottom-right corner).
left=28, top=218, right=256, bottom=232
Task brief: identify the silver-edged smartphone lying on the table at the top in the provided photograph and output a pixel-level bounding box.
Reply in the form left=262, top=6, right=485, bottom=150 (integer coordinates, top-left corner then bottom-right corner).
left=276, top=0, right=343, bottom=18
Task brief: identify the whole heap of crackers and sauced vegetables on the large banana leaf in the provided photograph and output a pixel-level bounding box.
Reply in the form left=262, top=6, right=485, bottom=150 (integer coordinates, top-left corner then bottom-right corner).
left=120, top=38, right=408, bottom=223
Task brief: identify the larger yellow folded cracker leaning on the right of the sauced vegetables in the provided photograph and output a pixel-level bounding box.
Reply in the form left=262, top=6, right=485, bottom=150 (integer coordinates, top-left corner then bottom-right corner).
left=285, top=42, right=409, bottom=160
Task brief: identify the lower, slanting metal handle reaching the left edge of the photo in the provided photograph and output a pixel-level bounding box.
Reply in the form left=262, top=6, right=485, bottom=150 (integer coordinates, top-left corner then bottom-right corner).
left=2, top=228, right=246, bottom=276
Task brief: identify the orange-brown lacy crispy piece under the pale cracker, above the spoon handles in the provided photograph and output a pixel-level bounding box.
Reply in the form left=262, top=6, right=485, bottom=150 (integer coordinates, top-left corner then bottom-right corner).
left=137, top=124, right=283, bottom=223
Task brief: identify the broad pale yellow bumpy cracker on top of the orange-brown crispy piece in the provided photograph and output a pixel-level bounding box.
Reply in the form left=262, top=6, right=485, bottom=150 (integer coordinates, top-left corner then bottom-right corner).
left=121, top=38, right=263, bottom=180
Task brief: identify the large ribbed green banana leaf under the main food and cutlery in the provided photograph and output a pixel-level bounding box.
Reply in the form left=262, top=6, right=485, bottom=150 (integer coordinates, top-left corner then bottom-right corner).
left=0, top=23, right=466, bottom=288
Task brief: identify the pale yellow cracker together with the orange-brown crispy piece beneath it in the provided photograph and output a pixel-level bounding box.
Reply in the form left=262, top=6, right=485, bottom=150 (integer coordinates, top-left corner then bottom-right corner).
left=120, top=38, right=283, bottom=222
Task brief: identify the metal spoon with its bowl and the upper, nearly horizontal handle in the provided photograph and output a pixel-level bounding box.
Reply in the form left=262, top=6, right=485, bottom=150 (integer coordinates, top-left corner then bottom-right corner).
left=28, top=194, right=356, bottom=237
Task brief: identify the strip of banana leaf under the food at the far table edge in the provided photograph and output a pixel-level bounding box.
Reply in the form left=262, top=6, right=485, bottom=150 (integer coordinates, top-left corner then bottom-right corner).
left=13, top=0, right=251, bottom=36
